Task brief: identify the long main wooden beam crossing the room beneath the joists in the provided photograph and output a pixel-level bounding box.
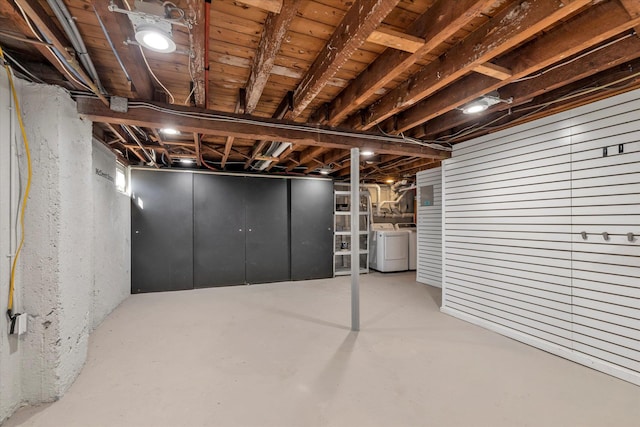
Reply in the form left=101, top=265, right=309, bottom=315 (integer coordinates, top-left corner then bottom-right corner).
left=77, top=98, right=449, bottom=159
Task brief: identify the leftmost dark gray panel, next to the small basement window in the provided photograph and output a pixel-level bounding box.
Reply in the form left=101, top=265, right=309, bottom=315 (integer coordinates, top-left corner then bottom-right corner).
left=131, top=170, right=193, bottom=293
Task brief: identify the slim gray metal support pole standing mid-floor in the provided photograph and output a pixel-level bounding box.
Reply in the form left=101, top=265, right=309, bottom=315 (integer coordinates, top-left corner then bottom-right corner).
left=351, top=148, right=360, bottom=331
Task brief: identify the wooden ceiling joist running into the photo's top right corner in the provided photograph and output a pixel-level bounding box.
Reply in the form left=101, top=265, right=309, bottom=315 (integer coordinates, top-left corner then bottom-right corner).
left=392, top=1, right=640, bottom=133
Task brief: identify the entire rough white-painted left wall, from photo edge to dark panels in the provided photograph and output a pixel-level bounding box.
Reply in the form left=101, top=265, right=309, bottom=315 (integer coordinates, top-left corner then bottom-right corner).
left=0, top=78, right=130, bottom=422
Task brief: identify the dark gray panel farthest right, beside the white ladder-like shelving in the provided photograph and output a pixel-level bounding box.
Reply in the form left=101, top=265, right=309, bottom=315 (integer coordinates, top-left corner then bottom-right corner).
left=291, top=179, right=333, bottom=280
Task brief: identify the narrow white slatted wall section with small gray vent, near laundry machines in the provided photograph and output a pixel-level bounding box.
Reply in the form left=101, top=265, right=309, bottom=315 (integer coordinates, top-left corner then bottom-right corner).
left=416, top=168, right=442, bottom=288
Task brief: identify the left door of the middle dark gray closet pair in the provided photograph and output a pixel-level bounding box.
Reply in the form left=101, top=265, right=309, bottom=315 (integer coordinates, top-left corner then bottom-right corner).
left=193, top=174, right=245, bottom=288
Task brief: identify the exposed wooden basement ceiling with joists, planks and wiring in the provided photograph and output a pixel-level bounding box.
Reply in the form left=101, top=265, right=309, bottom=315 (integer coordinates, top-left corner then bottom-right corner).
left=0, top=0, right=640, bottom=181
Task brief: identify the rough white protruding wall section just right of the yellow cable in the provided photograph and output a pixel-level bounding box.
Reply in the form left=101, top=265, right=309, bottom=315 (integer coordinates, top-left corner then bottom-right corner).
left=21, top=85, right=93, bottom=402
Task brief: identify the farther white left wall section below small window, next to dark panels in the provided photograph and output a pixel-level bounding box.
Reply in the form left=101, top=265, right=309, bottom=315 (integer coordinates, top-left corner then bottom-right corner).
left=91, top=142, right=131, bottom=329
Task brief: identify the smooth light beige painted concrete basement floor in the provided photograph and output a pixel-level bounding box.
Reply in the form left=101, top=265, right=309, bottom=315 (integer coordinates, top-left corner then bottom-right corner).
left=5, top=273, right=640, bottom=427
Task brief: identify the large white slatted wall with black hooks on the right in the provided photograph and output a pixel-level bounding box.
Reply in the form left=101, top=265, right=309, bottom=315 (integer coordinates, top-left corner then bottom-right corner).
left=442, top=91, right=640, bottom=385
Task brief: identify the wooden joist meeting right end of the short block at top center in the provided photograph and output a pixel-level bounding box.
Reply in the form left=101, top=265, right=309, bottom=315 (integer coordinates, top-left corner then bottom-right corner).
left=312, top=0, right=494, bottom=126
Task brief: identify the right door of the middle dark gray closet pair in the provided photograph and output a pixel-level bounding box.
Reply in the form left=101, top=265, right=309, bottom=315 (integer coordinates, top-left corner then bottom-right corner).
left=245, top=178, right=290, bottom=283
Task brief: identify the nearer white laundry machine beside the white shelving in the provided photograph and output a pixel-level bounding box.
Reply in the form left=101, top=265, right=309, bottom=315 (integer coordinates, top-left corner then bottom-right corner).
left=369, top=223, right=409, bottom=273
